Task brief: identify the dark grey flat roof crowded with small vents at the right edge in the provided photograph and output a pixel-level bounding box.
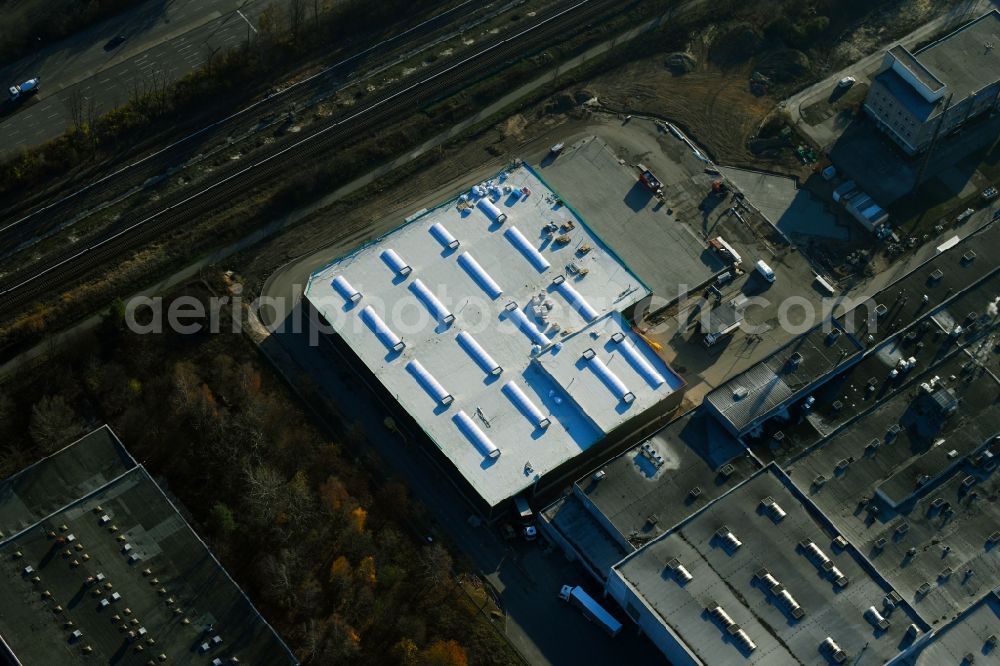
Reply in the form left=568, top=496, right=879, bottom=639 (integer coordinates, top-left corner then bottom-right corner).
left=789, top=351, right=1000, bottom=623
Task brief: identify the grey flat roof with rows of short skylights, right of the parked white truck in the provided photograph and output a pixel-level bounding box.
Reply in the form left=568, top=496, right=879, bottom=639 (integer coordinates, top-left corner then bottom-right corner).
left=613, top=465, right=926, bottom=664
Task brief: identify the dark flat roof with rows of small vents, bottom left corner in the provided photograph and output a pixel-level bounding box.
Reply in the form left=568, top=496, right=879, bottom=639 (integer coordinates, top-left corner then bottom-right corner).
left=0, top=427, right=297, bottom=665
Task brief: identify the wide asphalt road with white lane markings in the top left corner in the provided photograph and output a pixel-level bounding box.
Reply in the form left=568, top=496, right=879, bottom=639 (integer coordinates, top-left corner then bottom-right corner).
left=0, top=0, right=284, bottom=157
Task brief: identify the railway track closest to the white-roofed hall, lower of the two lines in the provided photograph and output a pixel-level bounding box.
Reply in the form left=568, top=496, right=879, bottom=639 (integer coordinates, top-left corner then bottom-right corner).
left=0, top=0, right=620, bottom=320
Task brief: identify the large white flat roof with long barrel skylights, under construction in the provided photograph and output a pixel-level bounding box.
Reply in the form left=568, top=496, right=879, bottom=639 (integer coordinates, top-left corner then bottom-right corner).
left=306, top=166, right=683, bottom=506
